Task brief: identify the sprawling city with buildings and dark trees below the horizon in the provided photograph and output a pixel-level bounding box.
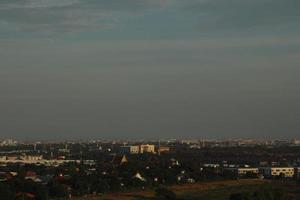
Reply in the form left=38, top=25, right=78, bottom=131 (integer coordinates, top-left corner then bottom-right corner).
left=0, top=139, right=300, bottom=200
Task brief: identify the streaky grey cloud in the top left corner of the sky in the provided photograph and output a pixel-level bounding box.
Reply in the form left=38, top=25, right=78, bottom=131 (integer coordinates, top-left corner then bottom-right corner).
left=0, top=0, right=168, bottom=32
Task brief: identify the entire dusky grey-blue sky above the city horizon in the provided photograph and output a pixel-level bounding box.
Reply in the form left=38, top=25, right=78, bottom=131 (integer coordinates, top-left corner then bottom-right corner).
left=0, top=0, right=300, bottom=139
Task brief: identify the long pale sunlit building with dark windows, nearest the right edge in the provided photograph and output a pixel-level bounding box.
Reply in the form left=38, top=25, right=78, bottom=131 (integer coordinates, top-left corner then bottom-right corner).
left=260, top=167, right=295, bottom=178
